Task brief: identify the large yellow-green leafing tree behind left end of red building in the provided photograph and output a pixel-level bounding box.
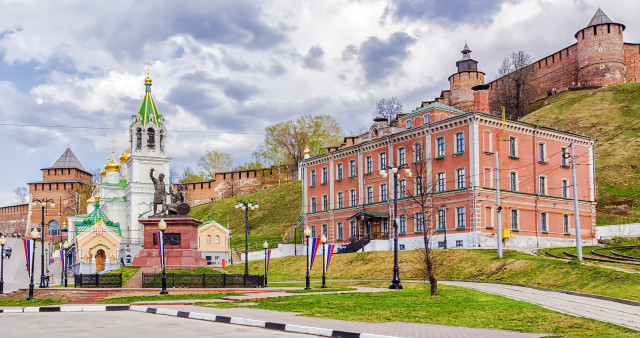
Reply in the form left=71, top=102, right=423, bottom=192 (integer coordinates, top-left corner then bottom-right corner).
left=254, top=114, right=342, bottom=169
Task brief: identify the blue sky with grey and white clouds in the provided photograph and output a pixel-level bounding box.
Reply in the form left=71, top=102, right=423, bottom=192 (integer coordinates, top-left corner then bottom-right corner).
left=0, top=0, right=640, bottom=206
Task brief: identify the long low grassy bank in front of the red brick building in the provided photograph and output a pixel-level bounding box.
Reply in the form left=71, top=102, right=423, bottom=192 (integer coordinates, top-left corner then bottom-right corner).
left=227, top=249, right=640, bottom=301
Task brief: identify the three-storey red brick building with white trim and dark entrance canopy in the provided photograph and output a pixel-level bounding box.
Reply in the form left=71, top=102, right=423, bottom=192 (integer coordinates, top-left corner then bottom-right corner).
left=302, top=91, right=596, bottom=250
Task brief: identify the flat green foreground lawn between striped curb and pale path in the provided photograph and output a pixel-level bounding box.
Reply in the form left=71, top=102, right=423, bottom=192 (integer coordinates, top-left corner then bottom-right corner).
left=244, top=283, right=637, bottom=337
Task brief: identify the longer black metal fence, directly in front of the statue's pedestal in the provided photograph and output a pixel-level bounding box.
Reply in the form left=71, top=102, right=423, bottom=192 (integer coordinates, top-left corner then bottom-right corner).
left=142, top=273, right=264, bottom=288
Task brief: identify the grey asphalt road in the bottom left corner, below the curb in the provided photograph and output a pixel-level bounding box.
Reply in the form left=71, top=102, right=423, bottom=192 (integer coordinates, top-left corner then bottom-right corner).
left=0, top=311, right=312, bottom=338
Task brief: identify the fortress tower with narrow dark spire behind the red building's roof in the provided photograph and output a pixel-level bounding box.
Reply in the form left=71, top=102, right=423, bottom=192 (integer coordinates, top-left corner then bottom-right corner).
left=449, top=42, right=484, bottom=110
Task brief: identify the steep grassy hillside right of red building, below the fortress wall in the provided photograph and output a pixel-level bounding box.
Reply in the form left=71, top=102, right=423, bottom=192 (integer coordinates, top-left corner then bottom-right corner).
left=525, top=83, right=640, bottom=225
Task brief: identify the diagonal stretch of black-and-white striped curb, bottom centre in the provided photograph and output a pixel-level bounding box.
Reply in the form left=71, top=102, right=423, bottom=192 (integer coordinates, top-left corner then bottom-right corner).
left=129, top=305, right=392, bottom=338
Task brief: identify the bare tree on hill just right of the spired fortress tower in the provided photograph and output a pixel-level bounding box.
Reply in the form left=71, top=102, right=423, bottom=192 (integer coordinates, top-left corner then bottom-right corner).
left=491, top=50, right=533, bottom=116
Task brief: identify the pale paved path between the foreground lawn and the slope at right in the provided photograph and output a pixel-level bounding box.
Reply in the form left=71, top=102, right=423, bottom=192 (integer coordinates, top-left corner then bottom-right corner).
left=438, top=281, right=640, bottom=330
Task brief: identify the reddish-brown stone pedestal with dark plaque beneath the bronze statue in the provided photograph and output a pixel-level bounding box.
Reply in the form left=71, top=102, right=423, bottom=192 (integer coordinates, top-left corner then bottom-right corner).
left=132, top=216, right=207, bottom=267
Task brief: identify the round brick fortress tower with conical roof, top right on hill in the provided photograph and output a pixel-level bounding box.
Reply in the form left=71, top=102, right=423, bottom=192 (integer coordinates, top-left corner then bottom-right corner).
left=574, top=8, right=626, bottom=86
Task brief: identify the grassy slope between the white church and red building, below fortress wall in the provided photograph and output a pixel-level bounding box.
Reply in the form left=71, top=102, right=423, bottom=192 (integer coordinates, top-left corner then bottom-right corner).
left=190, top=181, right=302, bottom=250
